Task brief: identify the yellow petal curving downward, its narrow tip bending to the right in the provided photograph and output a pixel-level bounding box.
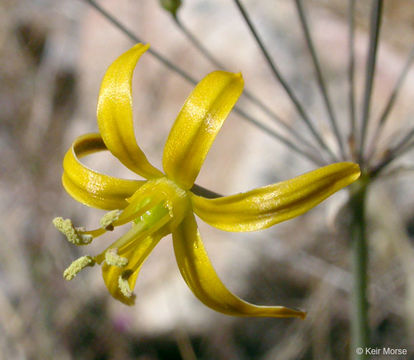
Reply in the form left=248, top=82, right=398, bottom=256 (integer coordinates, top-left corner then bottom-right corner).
left=173, top=213, right=306, bottom=318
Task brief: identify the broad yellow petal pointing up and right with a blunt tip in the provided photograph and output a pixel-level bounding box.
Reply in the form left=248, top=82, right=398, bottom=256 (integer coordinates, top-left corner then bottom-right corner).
left=163, top=71, right=243, bottom=190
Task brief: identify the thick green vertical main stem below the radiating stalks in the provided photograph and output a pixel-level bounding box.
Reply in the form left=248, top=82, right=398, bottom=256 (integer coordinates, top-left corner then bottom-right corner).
left=350, top=176, right=369, bottom=360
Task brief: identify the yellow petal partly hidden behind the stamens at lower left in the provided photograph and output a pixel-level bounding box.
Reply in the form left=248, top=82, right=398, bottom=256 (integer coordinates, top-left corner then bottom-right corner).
left=102, top=235, right=162, bottom=305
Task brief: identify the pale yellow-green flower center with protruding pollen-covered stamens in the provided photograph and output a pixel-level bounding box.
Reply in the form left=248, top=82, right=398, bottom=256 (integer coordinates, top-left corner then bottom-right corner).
left=54, top=177, right=191, bottom=301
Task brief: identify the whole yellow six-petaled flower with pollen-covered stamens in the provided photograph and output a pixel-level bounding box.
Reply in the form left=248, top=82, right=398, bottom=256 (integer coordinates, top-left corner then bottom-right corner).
left=54, top=44, right=360, bottom=318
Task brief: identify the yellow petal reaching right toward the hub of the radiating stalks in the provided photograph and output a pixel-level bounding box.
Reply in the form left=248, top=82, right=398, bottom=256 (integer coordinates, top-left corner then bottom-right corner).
left=191, top=162, right=360, bottom=231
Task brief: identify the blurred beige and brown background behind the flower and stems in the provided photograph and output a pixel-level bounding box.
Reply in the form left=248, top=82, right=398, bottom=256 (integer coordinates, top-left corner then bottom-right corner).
left=0, top=0, right=414, bottom=360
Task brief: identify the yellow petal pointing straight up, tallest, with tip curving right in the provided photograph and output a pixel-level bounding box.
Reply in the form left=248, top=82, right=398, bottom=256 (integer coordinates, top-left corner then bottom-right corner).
left=97, top=44, right=162, bottom=179
